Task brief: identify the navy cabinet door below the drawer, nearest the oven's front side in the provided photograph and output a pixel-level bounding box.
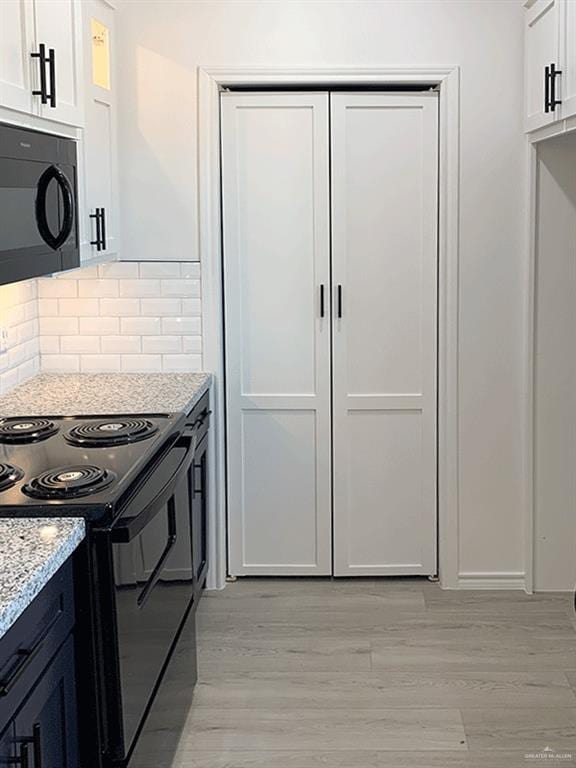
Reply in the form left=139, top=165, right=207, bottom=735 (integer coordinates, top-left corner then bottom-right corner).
left=14, top=635, right=78, bottom=768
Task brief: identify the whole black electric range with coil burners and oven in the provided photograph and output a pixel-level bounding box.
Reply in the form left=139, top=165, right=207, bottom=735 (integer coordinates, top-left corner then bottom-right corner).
left=0, top=404, right=209, bottom=768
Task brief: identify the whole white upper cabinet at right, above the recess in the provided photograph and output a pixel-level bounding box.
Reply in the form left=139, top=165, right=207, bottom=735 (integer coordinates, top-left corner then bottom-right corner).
left=525, top=0, right=576, bottom=132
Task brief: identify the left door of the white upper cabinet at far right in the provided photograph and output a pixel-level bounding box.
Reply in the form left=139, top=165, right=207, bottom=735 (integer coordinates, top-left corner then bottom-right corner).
left=525, top=0, right=562, bottom=131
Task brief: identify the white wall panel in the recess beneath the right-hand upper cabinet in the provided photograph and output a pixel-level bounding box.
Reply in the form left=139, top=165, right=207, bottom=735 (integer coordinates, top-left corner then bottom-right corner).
left=534, top=135, right=576, bottom=589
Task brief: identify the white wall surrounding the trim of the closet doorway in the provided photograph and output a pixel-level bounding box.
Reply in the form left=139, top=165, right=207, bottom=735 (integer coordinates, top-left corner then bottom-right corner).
left=119, top=0, right=524, bottom=576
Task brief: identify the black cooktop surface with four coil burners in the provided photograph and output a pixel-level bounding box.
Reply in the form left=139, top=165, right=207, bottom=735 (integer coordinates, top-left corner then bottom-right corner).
left=0, top=414, right=186, bottom=519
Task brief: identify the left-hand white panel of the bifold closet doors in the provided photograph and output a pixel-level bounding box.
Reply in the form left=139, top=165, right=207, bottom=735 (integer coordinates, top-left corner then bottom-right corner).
left=221, top=93, right=332, bottom=575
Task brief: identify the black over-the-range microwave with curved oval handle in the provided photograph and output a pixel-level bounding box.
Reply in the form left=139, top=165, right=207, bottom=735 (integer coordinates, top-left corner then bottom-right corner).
left=0, top=125, right=80, bottom=284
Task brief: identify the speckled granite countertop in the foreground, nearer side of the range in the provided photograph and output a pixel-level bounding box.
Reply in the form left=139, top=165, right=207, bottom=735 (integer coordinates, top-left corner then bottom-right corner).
left=0, top=517, right=85, bottom=637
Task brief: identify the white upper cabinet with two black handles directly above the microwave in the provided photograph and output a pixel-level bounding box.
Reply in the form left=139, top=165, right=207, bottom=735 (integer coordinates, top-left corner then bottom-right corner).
left=0, top=0, right=83, bottom=126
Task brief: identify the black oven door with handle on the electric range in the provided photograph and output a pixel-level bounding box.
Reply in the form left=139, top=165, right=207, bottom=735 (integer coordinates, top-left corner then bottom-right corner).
left=96, top=438, right=195, bottom=765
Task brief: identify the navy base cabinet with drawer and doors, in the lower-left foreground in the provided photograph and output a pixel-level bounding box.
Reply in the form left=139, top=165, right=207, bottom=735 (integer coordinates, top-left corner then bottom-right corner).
left=0, top=562, right=79, bottom=768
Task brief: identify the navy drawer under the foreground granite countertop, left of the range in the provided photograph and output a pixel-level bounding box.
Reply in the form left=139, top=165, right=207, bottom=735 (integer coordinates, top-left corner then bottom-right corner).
left=0, top=560, right=74, bottom=724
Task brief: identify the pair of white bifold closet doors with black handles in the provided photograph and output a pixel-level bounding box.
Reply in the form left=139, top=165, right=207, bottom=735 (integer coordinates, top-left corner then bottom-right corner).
left=222, top=92, right=438, bottom=576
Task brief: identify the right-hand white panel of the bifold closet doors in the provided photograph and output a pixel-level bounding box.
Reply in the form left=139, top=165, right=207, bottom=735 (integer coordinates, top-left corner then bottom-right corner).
left=332, top=94, right=438, bottom=576
